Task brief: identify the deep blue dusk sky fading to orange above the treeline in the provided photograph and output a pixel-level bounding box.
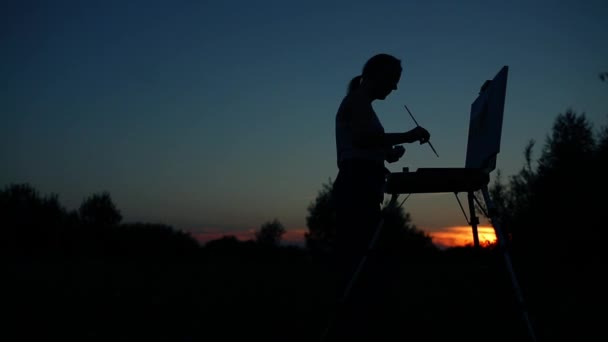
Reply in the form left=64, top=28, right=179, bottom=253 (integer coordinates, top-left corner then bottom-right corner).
left=0, top=0, right=608, bottom=246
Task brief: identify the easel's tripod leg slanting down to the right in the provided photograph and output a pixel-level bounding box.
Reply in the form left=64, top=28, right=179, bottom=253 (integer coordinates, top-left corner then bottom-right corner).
left=481, top=186, right=537, bottom=342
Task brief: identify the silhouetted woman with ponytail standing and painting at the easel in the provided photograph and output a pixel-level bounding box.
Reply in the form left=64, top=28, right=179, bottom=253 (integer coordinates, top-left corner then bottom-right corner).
left=331, top=53, right=430, bottom=340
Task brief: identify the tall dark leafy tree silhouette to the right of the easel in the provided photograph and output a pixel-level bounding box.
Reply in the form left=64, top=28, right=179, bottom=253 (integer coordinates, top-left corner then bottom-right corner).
left=491, top=110, right=605, bottom=258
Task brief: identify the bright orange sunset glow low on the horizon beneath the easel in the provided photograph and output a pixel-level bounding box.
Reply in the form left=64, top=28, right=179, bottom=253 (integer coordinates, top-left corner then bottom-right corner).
left=429, top=226, right=496, bottom=248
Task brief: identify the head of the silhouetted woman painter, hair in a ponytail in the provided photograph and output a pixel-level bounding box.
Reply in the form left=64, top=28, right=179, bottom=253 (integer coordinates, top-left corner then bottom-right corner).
left=348, top=53, right=403, bottom=100
